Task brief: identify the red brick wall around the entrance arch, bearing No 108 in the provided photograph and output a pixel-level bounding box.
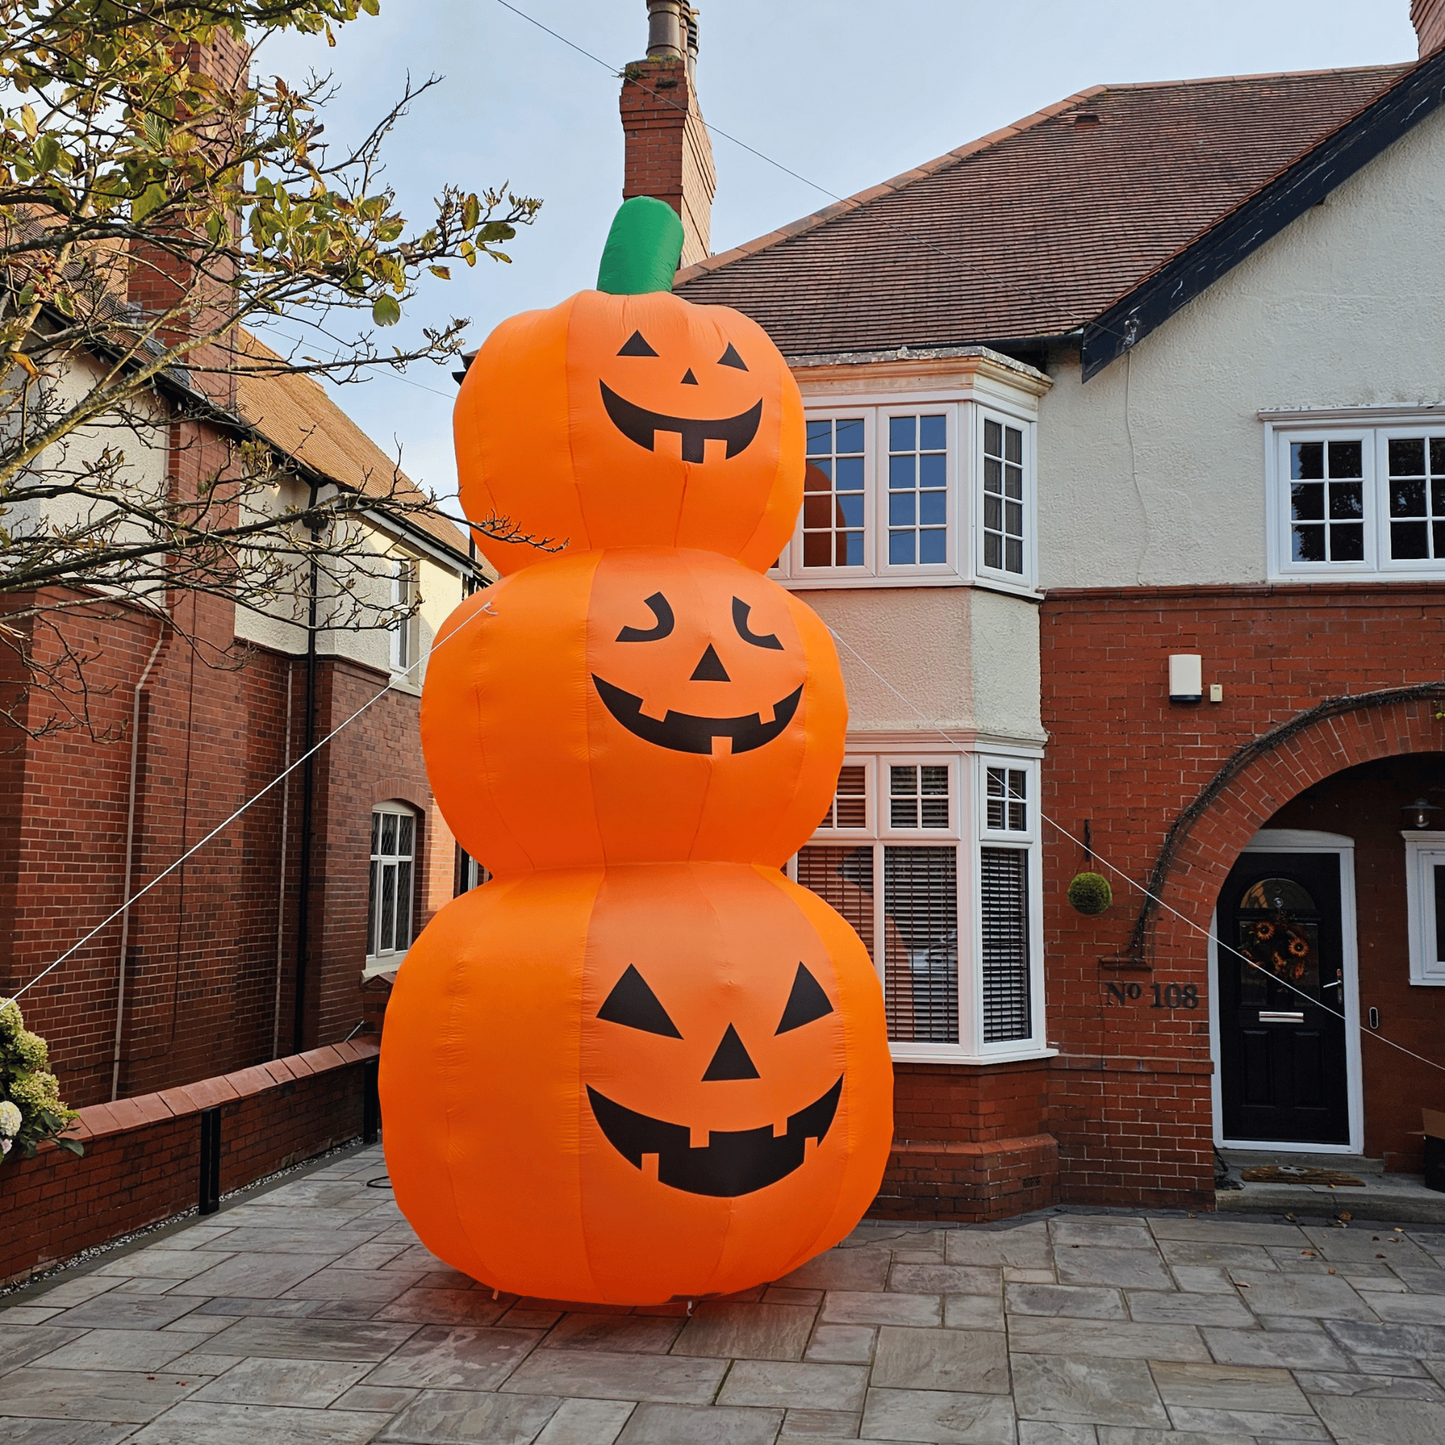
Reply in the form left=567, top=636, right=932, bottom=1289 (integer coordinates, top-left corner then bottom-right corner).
left=1040, top=585, right=1445, bottom=1207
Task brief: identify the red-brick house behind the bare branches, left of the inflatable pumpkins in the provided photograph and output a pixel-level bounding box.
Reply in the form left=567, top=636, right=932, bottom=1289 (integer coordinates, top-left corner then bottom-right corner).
left=0, top=316, right=481, bottom=1109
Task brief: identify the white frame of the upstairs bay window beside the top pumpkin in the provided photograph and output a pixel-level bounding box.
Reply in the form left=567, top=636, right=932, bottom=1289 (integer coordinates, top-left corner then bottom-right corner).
left=769, top=389, right=1038, bottom=597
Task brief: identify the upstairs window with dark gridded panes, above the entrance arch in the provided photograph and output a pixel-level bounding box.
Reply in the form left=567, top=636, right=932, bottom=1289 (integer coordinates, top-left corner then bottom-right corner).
left=1270, top=423, right=1445, bottom=581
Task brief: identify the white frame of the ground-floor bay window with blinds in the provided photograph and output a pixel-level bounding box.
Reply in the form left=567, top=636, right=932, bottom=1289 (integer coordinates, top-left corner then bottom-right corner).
left=788, top=740, right=1058, bottom=1064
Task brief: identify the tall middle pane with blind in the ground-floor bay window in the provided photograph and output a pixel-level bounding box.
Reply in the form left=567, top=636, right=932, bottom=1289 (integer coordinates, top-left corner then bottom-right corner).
left=883, top=847, right=958, bottom=1043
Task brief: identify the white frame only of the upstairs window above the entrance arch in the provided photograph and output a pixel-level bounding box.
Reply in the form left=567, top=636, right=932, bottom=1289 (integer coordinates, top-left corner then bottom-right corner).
left=1260, top=407, right=1445, bottom=582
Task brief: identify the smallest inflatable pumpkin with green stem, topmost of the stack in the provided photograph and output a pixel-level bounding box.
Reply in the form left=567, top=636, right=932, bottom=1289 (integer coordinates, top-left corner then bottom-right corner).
left=454, top=197, right=803, bottom=574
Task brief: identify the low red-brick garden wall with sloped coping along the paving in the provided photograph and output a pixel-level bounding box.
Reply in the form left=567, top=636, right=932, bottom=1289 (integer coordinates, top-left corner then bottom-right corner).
left=0, top=1039, right=379, bottom=1283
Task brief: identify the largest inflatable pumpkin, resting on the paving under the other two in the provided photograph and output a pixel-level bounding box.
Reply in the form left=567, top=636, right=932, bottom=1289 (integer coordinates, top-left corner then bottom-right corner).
left=381, top=863, right=893, bottom=1305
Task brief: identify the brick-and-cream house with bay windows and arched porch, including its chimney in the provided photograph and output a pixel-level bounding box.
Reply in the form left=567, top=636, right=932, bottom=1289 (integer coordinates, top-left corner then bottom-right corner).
left=621, top=0, right=1445, bottom=1220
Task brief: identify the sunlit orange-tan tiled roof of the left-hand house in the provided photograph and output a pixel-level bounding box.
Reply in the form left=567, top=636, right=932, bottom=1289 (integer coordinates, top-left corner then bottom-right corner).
left=236, top=332, right=467, bottom=556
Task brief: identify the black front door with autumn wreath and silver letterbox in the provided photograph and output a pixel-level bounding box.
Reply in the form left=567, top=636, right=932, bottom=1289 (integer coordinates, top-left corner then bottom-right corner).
left=1217, top=853, right=1350, bottom=1144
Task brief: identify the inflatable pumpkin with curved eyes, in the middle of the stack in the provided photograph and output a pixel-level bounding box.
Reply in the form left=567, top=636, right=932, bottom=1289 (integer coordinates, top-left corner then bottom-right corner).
left=422, top=548, right=848, bottom=877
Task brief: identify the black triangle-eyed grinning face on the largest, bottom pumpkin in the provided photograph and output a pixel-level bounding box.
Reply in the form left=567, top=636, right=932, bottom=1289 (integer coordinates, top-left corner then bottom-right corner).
left=587, top=962, right=842, bottom=1199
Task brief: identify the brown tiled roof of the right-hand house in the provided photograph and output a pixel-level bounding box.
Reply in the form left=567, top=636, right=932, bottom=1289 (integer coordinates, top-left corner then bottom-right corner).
left=678, top=64, right=1410, bottom=360
